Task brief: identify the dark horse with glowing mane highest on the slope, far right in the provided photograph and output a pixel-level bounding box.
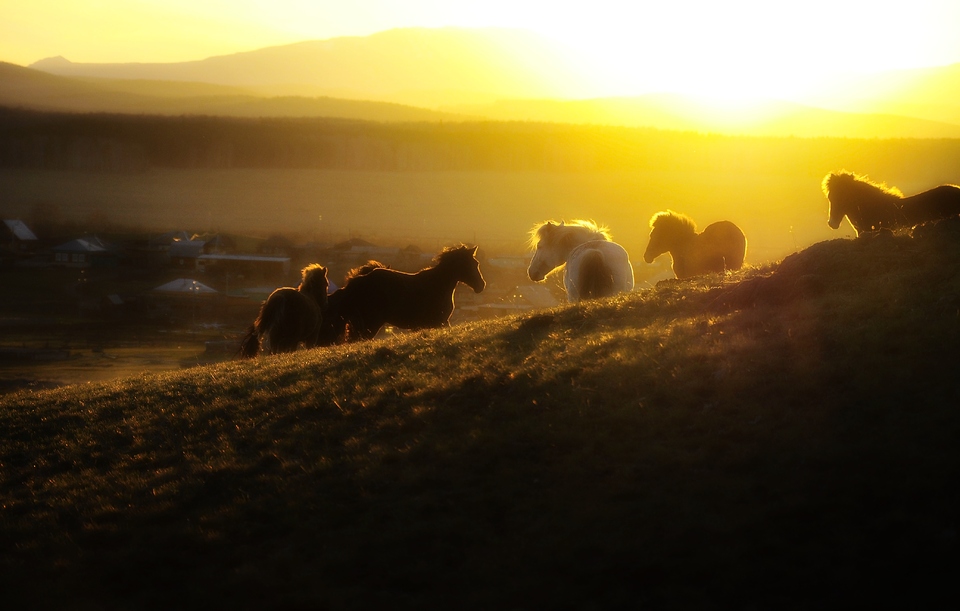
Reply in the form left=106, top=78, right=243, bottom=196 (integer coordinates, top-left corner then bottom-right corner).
left=821, top=172, right=960, bottom=235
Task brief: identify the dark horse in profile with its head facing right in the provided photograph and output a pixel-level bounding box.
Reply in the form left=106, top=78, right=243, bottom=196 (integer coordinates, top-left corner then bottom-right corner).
left=328, top=245, right=486, bottom=342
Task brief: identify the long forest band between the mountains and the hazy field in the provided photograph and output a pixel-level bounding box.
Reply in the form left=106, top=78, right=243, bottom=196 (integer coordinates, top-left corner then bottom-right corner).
left=0, top=108, right=960, bottom=181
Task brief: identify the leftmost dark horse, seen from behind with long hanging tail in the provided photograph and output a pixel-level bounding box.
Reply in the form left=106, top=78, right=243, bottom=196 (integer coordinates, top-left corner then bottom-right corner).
left=240, top=263, right=330, bottom=358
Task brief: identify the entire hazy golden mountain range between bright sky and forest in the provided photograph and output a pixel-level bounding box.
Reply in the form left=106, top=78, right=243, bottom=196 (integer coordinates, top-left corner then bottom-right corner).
left=0, top=28, right=960, bottom=138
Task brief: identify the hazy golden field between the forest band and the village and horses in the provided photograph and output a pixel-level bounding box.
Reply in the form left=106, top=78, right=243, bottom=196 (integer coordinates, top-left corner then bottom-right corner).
left=0, top=169, right=846, bottom=265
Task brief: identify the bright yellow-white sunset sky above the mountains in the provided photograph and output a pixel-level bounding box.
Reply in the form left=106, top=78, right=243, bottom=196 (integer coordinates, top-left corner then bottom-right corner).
left=0, top=0, right=960, bottom=94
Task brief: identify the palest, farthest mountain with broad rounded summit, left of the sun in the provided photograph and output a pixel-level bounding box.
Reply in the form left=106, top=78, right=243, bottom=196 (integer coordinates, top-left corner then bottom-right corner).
left=29, top=28, right=583, bottom=104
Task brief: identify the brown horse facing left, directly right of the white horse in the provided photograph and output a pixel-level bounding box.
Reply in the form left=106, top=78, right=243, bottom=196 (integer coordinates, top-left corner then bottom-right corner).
left=643, top=210, right=747, bottom=280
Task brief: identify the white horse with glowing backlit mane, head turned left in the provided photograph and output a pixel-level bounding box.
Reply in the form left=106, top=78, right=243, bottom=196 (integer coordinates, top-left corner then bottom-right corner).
left=527, top=221, right=633, bottom=303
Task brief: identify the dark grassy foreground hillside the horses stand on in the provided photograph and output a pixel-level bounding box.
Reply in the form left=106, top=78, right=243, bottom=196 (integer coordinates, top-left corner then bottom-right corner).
left=0, top=223, right=960, bottom=609
